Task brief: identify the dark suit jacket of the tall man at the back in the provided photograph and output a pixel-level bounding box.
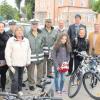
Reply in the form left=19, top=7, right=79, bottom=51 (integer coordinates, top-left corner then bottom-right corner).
left=68, top=24, right=87, bottom=43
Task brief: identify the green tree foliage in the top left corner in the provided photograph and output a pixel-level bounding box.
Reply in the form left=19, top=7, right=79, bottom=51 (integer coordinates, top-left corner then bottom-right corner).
left=0, top=1, right=19, bottom=20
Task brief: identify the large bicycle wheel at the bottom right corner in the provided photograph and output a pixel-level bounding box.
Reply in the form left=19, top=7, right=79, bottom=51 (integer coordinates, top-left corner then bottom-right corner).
left=83, top=72, right=100, bottom=100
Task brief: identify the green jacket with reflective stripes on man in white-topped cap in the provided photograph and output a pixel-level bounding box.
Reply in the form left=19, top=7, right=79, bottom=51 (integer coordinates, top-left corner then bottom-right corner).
left=26, top=30, right=45, bottom=62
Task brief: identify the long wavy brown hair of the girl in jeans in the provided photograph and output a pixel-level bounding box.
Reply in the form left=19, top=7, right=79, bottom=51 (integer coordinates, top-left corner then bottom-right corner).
left=54, top=33, right=71, bottom=52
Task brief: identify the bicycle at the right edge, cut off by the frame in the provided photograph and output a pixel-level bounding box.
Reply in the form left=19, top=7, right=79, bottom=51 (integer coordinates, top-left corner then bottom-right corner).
left=83, top=57, right=100, bottom=100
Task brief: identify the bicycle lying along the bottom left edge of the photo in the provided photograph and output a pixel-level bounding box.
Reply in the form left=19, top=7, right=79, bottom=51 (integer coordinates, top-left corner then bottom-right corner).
left=0, top=92, right=62, bottom=100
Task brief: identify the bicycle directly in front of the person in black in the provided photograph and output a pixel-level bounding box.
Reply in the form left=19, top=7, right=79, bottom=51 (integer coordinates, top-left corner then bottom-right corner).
left=68, top=51, right=93, bottom=98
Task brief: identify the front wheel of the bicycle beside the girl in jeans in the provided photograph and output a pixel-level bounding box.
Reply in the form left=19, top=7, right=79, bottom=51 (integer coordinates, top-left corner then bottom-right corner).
left=68, top=69, right=83, bottom=98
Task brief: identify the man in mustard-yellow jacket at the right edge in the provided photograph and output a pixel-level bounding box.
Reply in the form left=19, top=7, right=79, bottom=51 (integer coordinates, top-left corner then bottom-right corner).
left=88, top=22, right=100, bottom=55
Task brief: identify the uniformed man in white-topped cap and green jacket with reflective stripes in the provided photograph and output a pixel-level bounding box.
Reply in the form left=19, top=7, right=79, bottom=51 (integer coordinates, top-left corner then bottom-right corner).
left=26, top=19, right=45, bottom=90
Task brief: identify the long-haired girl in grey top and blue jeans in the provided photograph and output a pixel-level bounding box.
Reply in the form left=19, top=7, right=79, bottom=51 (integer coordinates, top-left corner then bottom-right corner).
left=52, top=34, right=71, bottom=93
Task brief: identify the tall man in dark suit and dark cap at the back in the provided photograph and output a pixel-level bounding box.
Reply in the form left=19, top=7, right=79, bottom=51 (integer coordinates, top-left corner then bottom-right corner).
left=68, top=14, right=87, bottom=74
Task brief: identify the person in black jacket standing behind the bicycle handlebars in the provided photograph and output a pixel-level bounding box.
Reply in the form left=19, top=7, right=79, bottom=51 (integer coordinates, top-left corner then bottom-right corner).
left=72, top=27, right=89, bottom=70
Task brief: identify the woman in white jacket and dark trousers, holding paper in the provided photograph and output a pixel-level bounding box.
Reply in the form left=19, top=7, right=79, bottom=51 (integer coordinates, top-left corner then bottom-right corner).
left=5, top=26, right=31, bottom=95
